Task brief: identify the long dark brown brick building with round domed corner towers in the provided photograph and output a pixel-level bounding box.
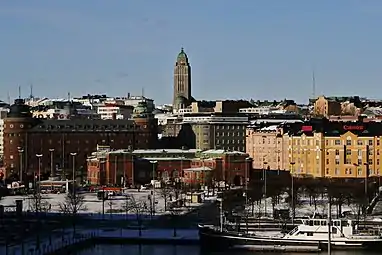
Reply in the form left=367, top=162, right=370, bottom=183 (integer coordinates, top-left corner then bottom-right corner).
left=4, top=99, right=157, bottom=180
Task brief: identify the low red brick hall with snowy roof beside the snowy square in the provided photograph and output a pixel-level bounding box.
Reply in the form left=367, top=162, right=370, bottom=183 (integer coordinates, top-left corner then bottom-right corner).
left=88, top=149, right=252, bottom=185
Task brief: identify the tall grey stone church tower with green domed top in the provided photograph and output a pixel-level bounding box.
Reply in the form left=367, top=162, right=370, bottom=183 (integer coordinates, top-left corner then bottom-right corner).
left=173, top=48, right=192, bottom=110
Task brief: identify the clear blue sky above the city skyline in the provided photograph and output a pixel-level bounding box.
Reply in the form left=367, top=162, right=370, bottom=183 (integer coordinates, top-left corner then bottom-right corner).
left=0, top=0, right=382, bottom=103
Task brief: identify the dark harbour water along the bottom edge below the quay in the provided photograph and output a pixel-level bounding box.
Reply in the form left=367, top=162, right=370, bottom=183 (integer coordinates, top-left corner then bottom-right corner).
left=77, top=245, right=381, bottom=255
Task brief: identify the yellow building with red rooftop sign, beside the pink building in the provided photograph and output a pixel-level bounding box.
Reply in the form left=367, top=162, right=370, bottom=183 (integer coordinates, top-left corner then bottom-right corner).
left=288, top=122, right=382, bottom=178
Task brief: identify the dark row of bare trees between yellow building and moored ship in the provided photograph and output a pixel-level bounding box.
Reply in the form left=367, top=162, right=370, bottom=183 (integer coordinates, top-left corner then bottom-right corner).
left=248, top=178, right=378, bottom=219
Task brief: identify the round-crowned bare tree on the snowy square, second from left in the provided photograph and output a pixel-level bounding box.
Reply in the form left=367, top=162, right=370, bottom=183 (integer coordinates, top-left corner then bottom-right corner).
left=58, top=192, right=87, bottom=235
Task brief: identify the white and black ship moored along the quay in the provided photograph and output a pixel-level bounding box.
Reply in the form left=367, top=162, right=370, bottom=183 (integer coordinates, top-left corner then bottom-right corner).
left=199, top=217, right=382, bottom=250
